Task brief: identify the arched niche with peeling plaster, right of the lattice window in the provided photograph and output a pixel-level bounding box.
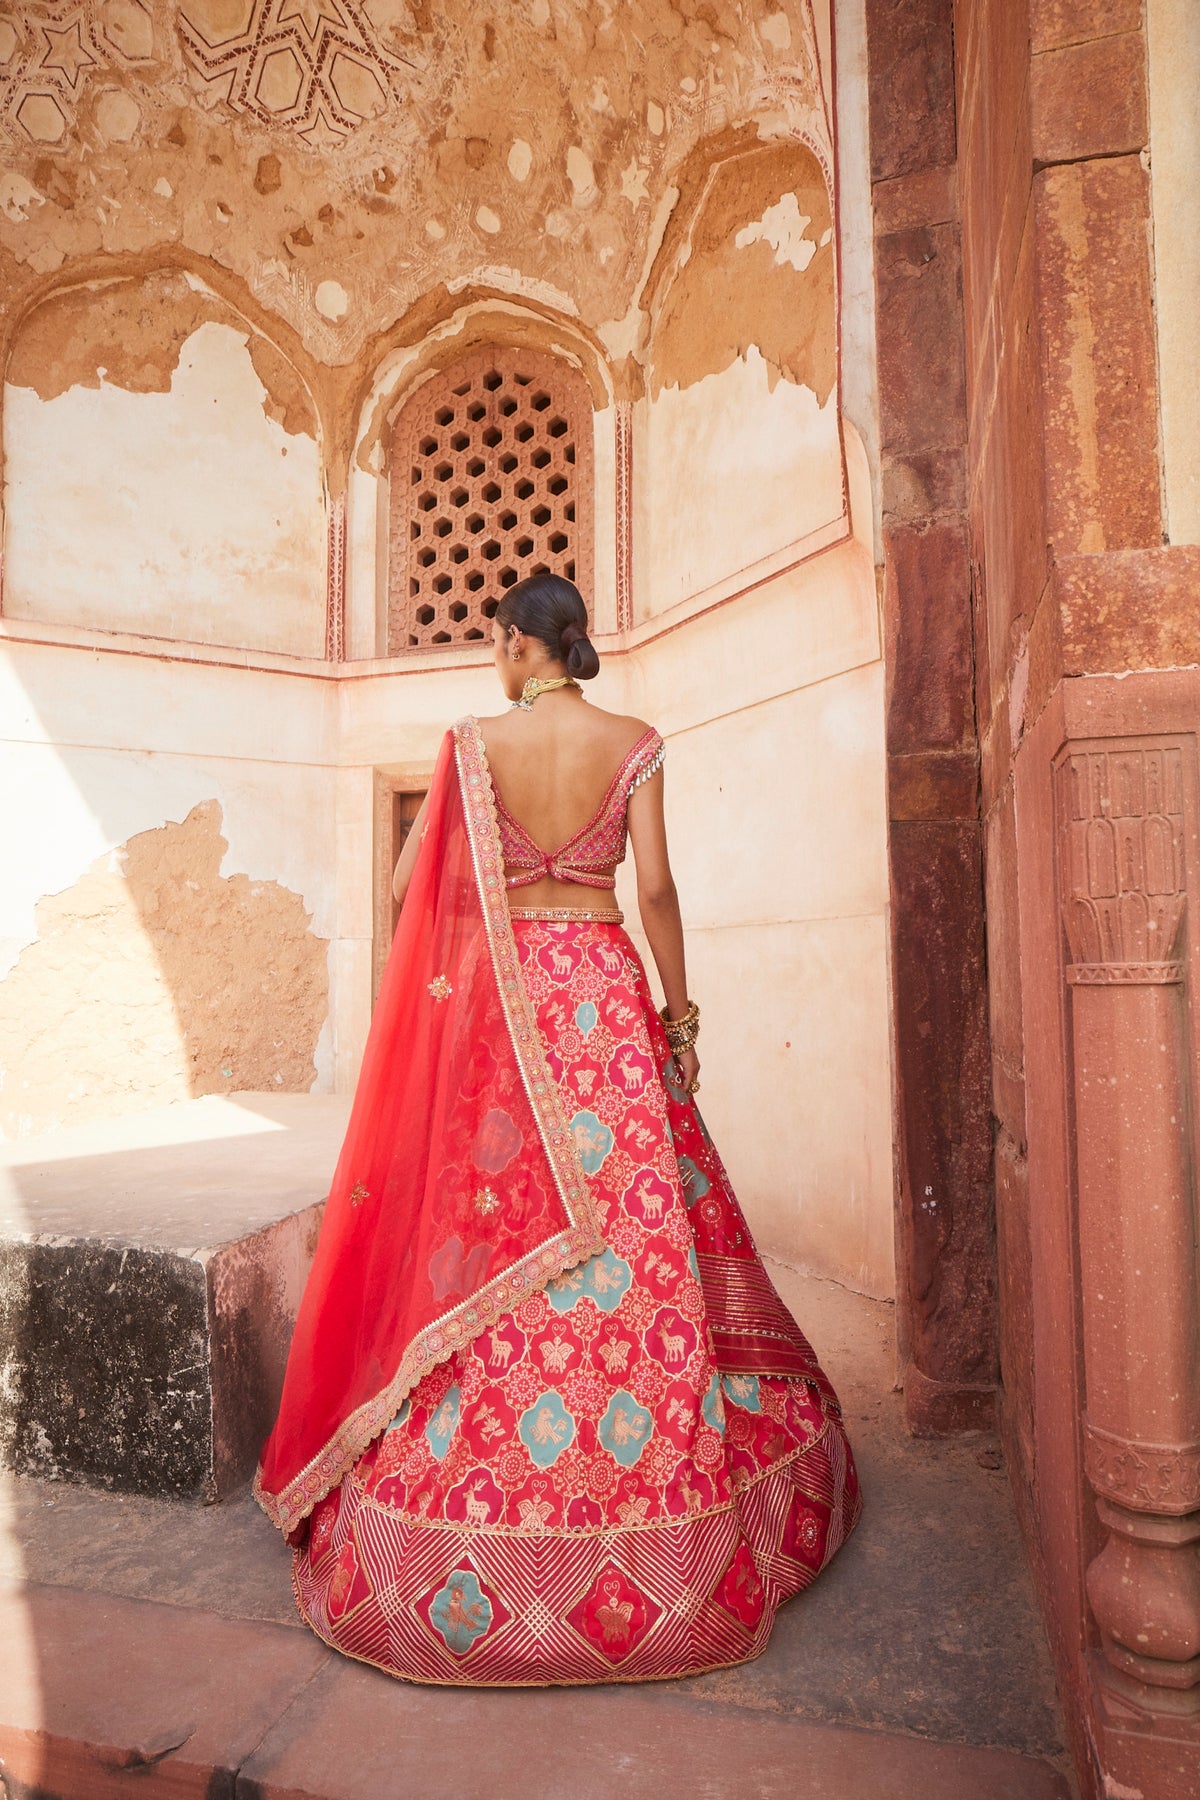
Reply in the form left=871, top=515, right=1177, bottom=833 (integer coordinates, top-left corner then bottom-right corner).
left=635, top=139, right=846, bottom=619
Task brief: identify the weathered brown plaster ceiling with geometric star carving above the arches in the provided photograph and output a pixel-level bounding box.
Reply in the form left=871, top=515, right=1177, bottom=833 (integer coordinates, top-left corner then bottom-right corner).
left=0, top=0, right=831, bottom=364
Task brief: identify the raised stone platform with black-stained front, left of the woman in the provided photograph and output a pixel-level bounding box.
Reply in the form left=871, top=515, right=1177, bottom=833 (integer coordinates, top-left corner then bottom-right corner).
left=0, top=1093, right=349, bottom=1499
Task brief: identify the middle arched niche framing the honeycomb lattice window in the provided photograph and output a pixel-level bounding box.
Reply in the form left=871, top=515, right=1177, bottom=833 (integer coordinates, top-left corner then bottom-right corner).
left=347, top=301, right=617, bottom=662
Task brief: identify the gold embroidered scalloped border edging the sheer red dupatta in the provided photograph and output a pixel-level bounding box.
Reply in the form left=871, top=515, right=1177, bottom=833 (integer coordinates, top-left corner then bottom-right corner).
left=252, top=716, right=604, bottom=1532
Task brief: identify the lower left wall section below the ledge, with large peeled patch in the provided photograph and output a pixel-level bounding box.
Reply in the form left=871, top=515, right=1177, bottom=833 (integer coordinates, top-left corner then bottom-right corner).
left=0, top=643, right=338, bottom=1136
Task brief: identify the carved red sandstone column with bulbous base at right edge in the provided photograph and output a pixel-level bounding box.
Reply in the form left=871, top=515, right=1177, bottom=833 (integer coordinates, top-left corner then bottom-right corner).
left=1054, top=738, right=1200, bottom=1717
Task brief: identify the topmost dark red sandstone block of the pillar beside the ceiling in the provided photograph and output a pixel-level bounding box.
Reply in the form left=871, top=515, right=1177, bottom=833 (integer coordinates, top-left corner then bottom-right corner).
left=867, top=0, right=954, bottom=180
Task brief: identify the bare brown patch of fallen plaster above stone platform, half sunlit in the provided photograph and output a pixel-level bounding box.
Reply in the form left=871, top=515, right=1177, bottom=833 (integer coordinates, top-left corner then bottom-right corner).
left=0, top=799, right=329, bottom=1138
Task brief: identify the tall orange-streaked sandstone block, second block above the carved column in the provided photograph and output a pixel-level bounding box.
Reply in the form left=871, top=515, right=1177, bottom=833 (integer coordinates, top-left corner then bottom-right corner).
left=1034, top=157, right=1162, bottom=556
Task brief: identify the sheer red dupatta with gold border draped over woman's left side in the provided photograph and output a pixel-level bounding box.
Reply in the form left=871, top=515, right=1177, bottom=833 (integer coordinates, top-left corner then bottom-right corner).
left=254, top=718, right=604, bottom=1532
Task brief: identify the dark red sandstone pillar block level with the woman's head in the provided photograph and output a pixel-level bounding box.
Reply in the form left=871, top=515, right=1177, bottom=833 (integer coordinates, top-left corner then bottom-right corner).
left=883, top=515, right=973, bottom=752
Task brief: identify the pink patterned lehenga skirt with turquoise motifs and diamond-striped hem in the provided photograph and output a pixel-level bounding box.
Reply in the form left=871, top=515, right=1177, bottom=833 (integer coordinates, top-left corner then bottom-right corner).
left=293, top=916, right=862, bottom=1687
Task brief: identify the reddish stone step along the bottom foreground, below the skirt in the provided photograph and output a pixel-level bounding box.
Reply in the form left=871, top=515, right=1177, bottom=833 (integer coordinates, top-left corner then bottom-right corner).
left=0, top=1586, right=1070, bottom=1800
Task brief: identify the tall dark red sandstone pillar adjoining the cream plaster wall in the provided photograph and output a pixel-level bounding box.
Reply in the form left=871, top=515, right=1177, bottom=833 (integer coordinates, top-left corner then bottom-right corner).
left=865, top=0, right=999, bottom=1436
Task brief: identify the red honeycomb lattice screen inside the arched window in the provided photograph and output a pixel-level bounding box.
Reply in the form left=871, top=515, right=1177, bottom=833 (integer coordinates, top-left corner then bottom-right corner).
left=387, top=346, right=592, bottom=655
